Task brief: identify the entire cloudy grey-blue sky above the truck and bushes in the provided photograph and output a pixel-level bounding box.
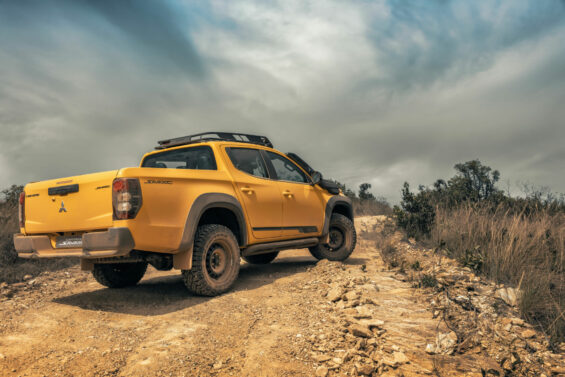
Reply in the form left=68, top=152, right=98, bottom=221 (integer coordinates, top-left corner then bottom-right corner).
left=0, top=0, right=565, bottom=202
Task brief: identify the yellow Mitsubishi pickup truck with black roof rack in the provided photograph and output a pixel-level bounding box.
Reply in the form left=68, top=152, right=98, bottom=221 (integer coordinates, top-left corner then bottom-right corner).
left=14, top=132, right=356, bottom=296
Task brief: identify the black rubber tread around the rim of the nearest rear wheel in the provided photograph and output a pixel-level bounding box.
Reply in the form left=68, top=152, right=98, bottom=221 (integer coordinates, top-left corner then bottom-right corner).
left=182, top=224, right=240, bottom=296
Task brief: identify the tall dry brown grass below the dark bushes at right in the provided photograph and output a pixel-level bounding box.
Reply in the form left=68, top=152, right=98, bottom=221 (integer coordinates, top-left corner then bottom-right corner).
left=432, top=205, right=565, bottom=341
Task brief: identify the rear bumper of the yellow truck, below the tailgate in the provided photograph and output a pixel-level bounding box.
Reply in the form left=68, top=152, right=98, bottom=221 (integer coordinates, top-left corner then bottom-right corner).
left=14, top=228, right=135, bottom=258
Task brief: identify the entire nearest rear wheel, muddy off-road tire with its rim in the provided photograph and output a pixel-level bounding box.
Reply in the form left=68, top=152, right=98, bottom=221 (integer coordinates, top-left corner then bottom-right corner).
left=182, top=224, right=240, bottom=296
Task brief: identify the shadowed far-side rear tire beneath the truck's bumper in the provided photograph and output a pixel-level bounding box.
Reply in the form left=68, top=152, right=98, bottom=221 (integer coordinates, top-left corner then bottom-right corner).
left=92, top=262, right=147, bottom=288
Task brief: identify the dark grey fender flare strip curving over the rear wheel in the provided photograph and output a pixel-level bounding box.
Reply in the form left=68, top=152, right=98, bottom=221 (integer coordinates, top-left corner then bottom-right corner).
left=173, top=192, right=247, bottom=270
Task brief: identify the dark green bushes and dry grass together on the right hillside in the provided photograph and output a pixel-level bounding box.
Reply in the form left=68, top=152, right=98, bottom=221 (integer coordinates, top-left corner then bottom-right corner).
left=394, top=160, right=565, bottom=341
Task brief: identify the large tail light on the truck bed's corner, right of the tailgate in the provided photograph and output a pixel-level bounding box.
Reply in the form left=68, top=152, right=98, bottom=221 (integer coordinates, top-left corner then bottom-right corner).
left=112, top=178, right=141, bottom=220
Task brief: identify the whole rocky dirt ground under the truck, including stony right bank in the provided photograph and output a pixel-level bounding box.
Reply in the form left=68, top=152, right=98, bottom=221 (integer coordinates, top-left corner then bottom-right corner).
left=0, top=217, right=565, bottom=377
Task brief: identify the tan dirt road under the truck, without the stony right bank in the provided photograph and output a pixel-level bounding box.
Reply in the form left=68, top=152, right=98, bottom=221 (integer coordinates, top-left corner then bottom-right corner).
left=0, top=219, right=560, bottom=376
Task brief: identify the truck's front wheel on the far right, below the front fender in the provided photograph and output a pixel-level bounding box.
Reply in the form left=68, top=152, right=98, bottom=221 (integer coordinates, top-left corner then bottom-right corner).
left=308, top=213, right=357, bottom=261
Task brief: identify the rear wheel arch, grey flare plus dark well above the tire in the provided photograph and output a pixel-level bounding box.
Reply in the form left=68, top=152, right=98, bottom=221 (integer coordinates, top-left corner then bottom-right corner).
left=173, top=193, right=247, bottom=270
